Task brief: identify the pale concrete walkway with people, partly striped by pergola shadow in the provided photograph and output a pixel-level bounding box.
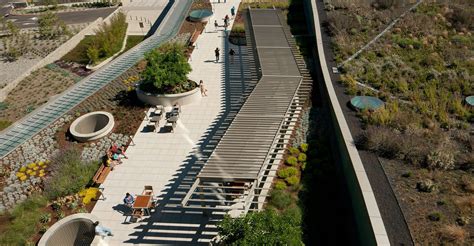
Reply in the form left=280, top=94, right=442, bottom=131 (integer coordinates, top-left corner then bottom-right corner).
left=92, top=0, right=257, bottom=245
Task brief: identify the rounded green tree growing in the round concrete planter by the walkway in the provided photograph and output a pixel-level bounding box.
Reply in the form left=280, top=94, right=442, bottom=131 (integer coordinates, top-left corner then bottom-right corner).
left=140, top=43, right=191, bottom=93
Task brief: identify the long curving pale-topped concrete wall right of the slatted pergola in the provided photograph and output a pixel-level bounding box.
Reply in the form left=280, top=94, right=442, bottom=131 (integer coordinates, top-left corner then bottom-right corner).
left=305, top=0, right=390, bottom=245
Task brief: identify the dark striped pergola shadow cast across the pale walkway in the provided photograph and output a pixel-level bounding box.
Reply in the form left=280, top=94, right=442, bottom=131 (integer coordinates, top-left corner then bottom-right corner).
left=125, top=32, right=258, bottom=245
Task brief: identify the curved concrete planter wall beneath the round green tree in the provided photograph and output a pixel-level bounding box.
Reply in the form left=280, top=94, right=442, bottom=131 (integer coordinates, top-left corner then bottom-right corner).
left=136, top=87, right=201, bottom=107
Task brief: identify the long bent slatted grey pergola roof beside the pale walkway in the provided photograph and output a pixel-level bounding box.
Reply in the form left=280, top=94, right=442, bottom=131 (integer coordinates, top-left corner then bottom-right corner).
left=182, top=9, right=311, bottom=215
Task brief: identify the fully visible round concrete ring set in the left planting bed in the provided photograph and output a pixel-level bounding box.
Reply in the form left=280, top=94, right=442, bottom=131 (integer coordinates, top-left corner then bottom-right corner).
left=69, top=111, right=115, bottom=142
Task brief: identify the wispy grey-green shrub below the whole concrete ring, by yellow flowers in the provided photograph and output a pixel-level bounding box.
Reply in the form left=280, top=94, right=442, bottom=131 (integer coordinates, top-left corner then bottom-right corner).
left=44, top=148, right=98, bottom=200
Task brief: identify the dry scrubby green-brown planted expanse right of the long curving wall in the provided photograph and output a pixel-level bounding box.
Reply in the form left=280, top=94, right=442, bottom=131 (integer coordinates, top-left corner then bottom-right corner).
left=325, top=0, right=474, bottom=245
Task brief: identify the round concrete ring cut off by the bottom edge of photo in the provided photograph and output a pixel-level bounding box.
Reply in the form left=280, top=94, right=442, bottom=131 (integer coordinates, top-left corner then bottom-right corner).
left=38, top=213, right=98, bottom=246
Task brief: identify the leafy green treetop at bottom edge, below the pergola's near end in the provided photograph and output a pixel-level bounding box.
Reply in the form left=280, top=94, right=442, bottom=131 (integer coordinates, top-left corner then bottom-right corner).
left=217, top=207, right=303, bottom=245
